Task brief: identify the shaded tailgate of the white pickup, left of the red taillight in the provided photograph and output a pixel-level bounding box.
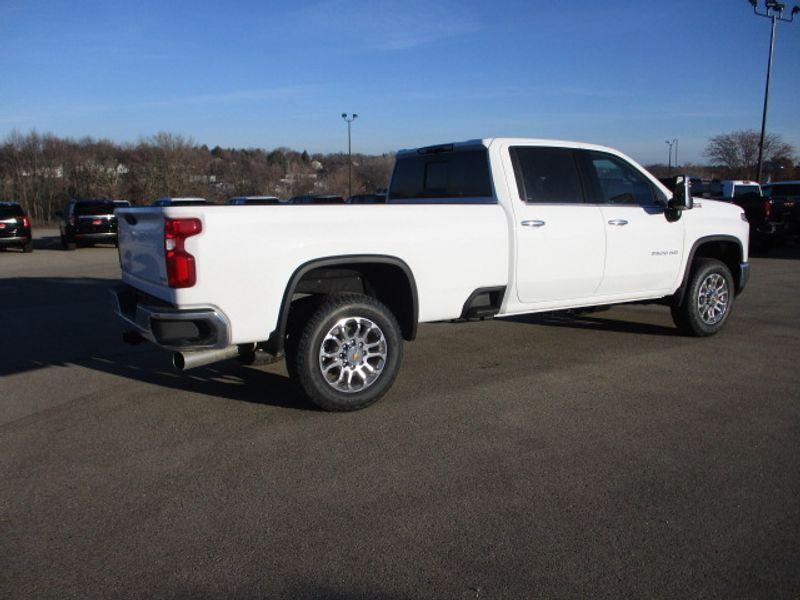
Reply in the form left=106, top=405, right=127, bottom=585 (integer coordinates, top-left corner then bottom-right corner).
left=116, top=208, right=169, bottom=290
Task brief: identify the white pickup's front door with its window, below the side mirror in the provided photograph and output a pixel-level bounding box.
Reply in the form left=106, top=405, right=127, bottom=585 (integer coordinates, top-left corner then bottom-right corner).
left=580, top=151, right=684, bottom=297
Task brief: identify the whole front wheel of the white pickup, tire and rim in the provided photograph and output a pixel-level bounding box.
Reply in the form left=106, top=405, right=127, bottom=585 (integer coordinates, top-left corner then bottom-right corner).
left=672, top=258, right=734, bottom=337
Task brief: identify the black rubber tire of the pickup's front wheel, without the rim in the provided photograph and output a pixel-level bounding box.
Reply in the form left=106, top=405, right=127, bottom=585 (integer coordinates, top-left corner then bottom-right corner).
left=672, top=258, right=735, bottom=337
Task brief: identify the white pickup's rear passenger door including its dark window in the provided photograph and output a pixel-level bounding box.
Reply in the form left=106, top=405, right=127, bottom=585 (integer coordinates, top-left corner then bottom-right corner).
left=504, top=145, right=605, bottom=304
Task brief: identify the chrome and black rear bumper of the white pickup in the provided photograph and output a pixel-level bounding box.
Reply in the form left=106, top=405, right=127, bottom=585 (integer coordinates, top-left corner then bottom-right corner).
left=111, top=285, right=230, bottom=350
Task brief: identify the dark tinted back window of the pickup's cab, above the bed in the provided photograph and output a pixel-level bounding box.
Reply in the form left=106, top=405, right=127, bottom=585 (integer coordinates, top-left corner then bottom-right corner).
left=389, top=148, right=495, bottom=203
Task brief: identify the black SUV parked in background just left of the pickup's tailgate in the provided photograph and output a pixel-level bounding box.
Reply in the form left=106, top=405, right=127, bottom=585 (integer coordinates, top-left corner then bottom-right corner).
left=56, top=200, right=119, bottom=250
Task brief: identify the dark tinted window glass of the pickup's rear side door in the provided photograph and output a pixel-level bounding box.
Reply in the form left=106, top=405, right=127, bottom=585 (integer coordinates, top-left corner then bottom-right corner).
left=509, top=146, right=584, bottom=204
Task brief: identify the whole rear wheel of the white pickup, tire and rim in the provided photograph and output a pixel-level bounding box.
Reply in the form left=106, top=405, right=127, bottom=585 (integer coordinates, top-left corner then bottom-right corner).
left=287, top=294, right=403, bottom=411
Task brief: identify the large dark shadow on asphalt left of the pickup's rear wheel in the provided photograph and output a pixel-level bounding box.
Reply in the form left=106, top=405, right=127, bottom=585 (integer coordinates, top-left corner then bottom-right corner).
left=0, top=277, right=316, bottom=410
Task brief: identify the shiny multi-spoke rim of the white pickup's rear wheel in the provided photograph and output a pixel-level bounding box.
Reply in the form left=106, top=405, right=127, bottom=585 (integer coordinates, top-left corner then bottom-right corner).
left=319, top=317, right=388, bottom=394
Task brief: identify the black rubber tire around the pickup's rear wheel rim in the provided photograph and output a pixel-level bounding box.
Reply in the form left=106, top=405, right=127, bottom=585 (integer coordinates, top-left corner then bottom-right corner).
left=286, top=294, right=403, bottom=412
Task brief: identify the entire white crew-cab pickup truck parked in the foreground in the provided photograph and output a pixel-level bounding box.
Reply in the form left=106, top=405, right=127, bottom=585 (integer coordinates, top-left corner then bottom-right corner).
left=115, top=138, right=749, bottom=411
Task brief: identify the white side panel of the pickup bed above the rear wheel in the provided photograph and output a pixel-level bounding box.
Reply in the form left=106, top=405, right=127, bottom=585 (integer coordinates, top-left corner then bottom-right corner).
left=163, top=204, right=508, bottom=343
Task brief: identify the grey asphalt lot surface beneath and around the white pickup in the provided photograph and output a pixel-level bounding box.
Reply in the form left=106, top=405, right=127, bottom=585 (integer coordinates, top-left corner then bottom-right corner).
left=0, top=227, right=800, bottom=599
